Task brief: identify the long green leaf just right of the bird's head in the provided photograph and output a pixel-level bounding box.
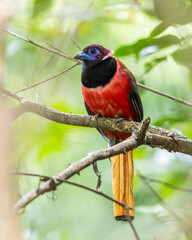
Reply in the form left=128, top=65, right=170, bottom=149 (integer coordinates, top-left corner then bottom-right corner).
left=115, top=35, right=180, bottom=57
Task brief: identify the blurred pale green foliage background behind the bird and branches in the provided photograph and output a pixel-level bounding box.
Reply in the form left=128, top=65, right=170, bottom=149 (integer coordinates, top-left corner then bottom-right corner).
left=5, top=0, right=192, bottom=240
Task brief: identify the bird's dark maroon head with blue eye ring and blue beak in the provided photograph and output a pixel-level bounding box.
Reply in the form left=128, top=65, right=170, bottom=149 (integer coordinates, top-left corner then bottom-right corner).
left=74, top=44, right=114, bottom=66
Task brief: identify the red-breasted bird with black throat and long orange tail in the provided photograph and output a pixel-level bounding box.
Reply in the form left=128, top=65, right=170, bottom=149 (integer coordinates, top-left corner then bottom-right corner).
left=74, top=44, right=143, bottom=221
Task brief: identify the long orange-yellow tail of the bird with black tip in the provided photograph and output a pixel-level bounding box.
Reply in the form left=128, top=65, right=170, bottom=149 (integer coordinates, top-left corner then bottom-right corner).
left=111, top=151, right=134, bottom=221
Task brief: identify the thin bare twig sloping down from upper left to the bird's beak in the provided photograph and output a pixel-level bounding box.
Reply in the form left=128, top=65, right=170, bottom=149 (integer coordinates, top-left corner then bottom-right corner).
left=3, top=29, right=81, bottom=63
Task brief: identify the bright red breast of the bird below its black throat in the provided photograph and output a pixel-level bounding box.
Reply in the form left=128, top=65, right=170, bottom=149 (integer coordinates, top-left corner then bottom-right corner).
left=82, top=73, right=132, bottom=119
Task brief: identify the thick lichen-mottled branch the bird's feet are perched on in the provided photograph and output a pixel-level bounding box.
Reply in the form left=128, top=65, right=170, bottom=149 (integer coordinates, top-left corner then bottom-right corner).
left=6, top=94, right=192, bottom=156
